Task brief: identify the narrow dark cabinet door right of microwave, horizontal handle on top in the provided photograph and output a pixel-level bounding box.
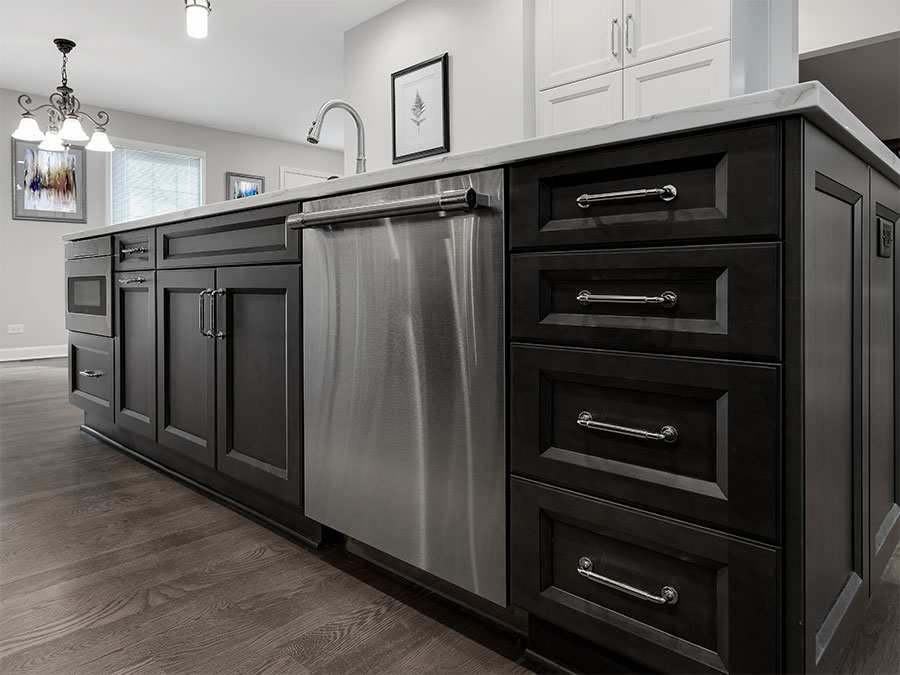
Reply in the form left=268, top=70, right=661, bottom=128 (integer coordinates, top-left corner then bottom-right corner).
left=113, top=272, right=156, bottom=440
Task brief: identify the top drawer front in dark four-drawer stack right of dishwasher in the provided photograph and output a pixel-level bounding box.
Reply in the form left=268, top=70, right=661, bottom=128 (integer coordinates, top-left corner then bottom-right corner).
left=509, top=124, right=781, bottom=249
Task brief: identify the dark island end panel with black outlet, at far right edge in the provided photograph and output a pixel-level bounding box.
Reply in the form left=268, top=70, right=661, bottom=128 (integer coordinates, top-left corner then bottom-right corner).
left=868, top=169, right=900, bottom=588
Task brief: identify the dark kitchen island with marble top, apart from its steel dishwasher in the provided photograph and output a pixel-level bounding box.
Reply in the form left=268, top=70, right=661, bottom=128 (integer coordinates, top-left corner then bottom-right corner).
left=67, top=83, right=900, bottom=672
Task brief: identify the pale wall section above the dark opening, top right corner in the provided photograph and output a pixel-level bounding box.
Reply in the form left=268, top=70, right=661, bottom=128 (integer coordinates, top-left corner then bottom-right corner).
left=798, top=0, right=900, bottom=55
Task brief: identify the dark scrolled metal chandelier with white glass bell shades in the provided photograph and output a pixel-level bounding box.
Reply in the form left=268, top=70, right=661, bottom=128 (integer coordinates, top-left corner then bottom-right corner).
left=12, top=38, right=115, bottom=152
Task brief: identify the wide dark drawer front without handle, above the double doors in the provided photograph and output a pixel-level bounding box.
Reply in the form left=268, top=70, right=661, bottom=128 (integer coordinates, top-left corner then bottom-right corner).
left=156, top=203, right=300, bottom=268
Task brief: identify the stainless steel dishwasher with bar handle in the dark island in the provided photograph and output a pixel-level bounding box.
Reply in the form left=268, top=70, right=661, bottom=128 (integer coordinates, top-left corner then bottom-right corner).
left=288, top=170, right=507, bottom=606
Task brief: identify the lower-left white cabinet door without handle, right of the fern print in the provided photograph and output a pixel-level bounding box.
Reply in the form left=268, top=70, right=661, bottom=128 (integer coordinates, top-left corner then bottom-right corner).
left=537, top=70, right=622, bottom=136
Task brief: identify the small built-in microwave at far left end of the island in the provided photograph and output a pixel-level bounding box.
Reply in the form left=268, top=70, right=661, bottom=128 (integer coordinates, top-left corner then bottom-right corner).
left=66, top=237, right=113, bottom=337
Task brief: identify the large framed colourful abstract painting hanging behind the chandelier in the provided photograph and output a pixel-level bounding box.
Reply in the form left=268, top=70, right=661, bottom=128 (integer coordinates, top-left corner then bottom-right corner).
left=12, top=138, right=87, bottom=223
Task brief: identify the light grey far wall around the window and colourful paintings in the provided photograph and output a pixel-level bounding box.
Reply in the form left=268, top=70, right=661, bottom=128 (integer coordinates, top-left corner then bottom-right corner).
left=0, top=89, right=342, bottom=360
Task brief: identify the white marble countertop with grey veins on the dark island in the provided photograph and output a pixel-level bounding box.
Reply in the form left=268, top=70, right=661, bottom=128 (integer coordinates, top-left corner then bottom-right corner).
left=63, top=82, right=900, bottom=241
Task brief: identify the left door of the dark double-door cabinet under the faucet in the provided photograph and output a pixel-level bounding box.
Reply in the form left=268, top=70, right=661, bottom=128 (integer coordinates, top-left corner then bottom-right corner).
left=156, top=270, right=217, bottom=466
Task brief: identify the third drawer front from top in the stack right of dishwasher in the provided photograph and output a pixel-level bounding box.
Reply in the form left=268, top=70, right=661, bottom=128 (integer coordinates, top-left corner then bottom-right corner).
left=510, top=345, right=781, bottom=542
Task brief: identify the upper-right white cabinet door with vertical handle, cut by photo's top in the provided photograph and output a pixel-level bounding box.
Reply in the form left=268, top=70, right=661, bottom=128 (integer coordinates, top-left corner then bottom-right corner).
left=624, top=0, right=731, bottom=67
